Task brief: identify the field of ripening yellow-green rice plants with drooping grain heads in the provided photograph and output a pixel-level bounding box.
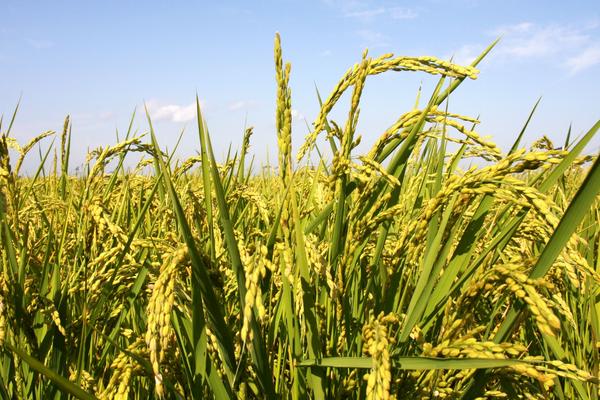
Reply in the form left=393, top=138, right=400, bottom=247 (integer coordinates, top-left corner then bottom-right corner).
left=0, top=35, right=600, bottom=399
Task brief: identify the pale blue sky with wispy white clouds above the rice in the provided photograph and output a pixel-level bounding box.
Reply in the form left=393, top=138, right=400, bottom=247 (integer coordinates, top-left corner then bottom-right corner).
left=0, top=0, right=600, bottom=172
